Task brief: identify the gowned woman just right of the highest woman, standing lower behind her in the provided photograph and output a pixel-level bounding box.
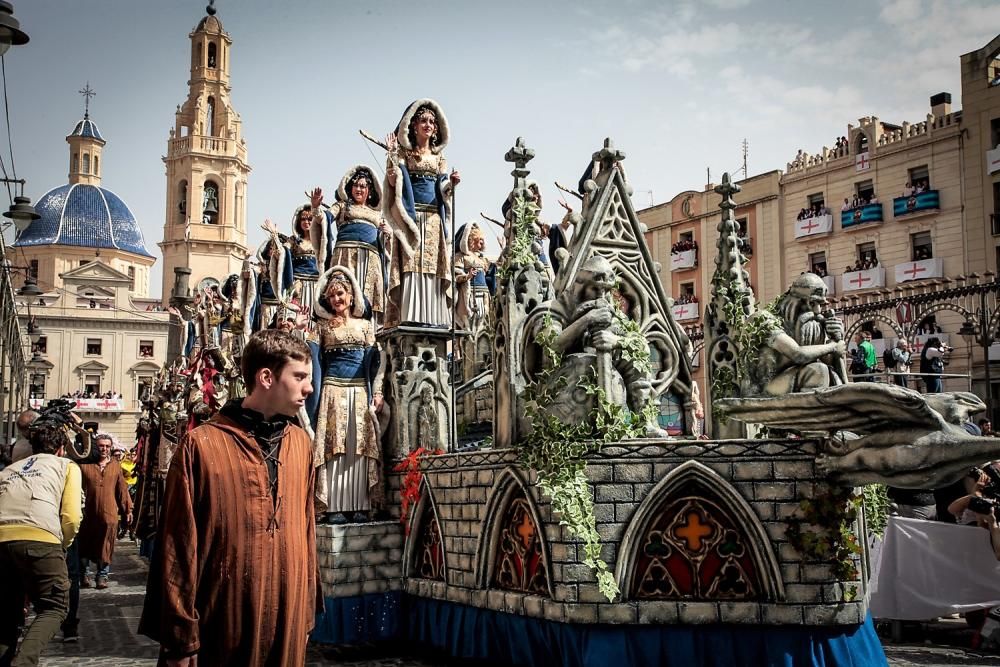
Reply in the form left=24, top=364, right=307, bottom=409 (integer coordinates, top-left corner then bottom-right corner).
left=454, top=222, right=497, bottom=333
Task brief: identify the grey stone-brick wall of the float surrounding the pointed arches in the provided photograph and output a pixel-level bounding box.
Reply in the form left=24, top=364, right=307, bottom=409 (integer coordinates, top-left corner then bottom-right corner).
left=378, top=440, right=867, bottom=625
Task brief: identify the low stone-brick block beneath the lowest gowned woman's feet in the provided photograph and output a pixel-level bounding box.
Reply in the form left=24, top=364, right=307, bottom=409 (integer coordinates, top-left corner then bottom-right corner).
left=316, top=521, right=403, bottom=598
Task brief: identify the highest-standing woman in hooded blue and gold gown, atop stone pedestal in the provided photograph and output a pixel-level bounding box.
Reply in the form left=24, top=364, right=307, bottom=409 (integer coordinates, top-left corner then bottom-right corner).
left=384, top=99, right=461, bottom=327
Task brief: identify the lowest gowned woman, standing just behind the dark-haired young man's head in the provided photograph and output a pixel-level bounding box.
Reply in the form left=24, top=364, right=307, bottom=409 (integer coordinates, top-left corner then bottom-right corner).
left=313, top=266, right=383, bottom=523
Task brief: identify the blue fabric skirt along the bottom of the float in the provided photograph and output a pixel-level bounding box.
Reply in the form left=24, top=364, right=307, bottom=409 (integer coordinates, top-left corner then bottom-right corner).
left=311, top=592, right=888, bottom=667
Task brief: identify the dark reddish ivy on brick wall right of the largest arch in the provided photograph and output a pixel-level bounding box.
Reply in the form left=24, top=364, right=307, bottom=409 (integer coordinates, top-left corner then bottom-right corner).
left=785, top=486, right=863, bottom=602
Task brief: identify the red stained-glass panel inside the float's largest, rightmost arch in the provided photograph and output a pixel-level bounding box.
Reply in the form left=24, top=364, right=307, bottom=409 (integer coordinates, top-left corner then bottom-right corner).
left=630, top=484, right=762, bottom=600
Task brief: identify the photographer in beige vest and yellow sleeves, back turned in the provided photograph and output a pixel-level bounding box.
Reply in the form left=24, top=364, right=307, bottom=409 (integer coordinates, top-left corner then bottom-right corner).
left=0, top=419, right=83, bottom=667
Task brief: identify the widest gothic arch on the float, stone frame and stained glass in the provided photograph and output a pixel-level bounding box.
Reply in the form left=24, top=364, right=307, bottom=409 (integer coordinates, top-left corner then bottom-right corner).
left=615, top=461, right=785, bottom=601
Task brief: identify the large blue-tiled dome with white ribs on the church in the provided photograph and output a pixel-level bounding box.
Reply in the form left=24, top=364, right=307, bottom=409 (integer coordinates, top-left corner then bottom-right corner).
left=14, top=185, right=152, bottom=257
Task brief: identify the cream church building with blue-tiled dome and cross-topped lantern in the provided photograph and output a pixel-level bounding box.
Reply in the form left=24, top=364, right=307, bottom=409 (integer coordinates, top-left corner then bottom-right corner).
left=13, top=112, right=170, bottom=443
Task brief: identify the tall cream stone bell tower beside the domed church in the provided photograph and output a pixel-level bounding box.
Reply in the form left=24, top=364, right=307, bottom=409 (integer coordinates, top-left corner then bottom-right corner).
left=159, top=0, right=250, bottom=304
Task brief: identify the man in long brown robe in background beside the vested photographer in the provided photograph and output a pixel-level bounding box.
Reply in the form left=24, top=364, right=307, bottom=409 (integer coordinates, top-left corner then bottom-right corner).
left=76, top=433, right=132, bottom=588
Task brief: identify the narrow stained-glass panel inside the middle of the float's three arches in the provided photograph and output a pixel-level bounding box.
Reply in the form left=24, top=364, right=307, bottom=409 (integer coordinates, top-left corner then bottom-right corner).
left=493, top=496, right=549, bottom=595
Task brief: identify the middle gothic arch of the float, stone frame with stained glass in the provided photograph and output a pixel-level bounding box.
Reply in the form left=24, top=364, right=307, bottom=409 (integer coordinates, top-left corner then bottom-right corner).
left=476, top=466, right=553, bottom=598
